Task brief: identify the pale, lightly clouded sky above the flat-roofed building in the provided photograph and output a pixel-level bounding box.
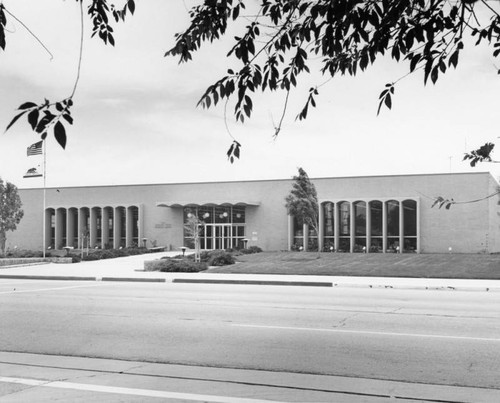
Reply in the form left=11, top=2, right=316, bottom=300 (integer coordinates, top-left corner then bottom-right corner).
left=0, top=0, right=500, bottom=188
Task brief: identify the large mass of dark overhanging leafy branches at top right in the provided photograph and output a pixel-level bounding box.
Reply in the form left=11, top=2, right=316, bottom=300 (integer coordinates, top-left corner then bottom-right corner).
left=169, top=0, right=500, bottom=159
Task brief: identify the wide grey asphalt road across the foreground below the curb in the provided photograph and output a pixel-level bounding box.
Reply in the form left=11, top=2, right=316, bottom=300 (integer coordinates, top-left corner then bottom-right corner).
left=0, top=280, right=500, bottom=402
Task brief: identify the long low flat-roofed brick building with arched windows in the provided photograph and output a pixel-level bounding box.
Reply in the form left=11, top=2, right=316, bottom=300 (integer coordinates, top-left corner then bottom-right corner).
left=7, top=172, right=500, bottom=253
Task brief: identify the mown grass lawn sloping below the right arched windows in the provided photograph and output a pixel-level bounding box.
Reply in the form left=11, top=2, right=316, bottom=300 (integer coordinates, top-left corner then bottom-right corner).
left=208, top=252, right=500, bottom=279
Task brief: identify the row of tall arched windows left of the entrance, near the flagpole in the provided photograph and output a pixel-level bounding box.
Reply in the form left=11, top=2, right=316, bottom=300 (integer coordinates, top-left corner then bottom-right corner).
left=44, top=205, right=143, bottom=249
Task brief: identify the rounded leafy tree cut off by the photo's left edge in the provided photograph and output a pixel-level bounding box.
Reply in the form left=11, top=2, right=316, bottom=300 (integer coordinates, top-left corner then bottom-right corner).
left=0, top=178, right=24, bottom=255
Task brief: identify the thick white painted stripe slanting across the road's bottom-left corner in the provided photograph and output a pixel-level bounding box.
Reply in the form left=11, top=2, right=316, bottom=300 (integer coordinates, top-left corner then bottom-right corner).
left=0, top=376, right=283, bottom=403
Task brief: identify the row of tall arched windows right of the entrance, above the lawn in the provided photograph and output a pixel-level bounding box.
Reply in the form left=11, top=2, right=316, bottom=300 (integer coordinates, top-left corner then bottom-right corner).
left=291, top=198, right=419, bottom=253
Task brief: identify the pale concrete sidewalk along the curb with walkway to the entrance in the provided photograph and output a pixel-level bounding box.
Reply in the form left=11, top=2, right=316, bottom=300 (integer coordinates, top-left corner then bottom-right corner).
left=0, top=252, right=500, bottom=292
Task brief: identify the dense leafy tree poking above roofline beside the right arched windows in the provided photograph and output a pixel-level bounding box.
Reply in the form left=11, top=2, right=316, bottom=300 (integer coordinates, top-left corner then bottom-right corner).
left=285, top=168, right=319, bottom=249
